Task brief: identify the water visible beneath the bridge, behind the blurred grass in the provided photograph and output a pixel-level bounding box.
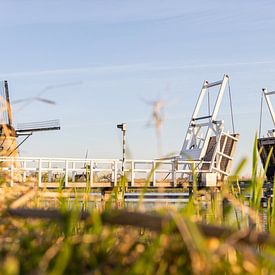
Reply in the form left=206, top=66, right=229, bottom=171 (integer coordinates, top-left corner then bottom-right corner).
left=27, top=192, right=268, bottom=230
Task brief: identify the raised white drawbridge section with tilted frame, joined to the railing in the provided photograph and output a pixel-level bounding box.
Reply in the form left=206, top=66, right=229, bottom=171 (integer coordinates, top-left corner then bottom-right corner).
left=179, top=75, right=239, bottom=185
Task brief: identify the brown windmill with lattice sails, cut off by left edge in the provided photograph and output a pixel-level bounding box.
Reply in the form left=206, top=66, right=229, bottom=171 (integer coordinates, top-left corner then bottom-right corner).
left=0, top=80, right=60, bottom=156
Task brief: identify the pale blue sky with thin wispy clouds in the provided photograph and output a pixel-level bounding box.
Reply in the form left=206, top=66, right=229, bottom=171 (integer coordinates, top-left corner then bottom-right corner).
left=0, top=0, right=275, bottom=176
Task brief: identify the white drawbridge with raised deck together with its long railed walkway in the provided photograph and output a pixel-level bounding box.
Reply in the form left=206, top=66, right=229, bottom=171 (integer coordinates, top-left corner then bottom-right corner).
left=0, top=75, right=239, bottom=188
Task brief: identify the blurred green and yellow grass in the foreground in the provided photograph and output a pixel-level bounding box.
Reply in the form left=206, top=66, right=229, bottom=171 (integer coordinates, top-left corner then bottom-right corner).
left=0, top=139, right=275, bottom=274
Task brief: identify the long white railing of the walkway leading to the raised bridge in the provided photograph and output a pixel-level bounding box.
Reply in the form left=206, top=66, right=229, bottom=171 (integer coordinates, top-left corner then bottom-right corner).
left=0, top=157, right=210, bottom=188
